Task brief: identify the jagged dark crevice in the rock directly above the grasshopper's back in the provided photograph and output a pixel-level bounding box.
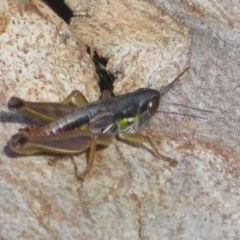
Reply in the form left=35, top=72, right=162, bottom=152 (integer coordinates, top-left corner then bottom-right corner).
left=87, top=47, right=116, bottom=95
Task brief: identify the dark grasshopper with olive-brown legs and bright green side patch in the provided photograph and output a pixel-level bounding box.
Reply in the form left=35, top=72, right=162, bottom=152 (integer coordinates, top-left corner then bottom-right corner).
left=8, top=68, right=189, bottom=179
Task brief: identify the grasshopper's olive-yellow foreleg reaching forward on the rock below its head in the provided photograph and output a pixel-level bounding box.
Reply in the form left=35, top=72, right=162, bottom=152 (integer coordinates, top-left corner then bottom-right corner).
left=118, top=133, right=177, bottom=167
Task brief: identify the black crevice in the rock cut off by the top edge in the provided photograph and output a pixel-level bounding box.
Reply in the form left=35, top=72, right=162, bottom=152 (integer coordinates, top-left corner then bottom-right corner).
left=42, top=0, right=73, bottom=24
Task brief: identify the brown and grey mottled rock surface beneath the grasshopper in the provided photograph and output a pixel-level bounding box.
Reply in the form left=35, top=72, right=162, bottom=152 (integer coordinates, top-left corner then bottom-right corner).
left=0, top=0, right=240, bottom=239
